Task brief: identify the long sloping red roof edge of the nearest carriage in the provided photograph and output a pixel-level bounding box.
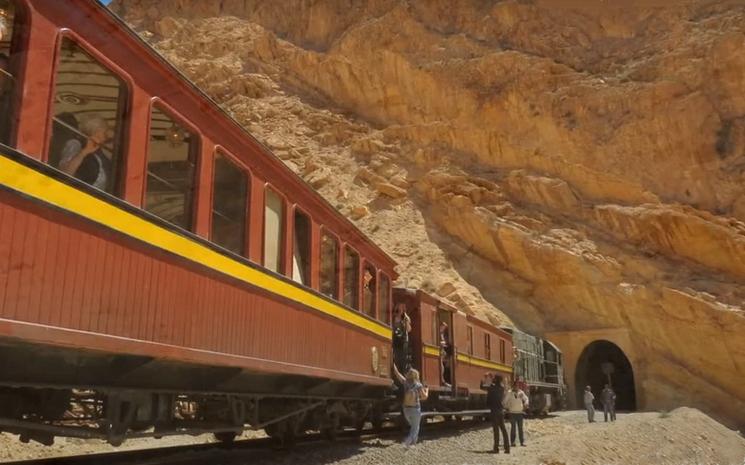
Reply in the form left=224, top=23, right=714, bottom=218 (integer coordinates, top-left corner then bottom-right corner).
left=96, top=0, right=398, bottom=272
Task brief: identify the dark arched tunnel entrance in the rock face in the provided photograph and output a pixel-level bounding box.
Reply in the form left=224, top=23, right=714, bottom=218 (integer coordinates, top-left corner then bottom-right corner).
left=575, top=341, right=636, bottom=410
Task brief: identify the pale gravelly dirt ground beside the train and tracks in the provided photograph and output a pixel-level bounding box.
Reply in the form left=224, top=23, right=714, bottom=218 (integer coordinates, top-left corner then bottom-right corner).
left=0, top=408, right=745, bottom=465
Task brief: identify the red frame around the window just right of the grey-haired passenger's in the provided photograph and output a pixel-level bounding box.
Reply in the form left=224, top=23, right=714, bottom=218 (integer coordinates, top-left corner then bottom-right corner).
left=140, top=96, right=201, bottom=234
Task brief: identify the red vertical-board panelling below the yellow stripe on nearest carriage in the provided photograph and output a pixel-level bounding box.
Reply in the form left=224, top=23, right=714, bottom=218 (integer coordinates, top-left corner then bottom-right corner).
left=0, top=193, right=389, bottom=382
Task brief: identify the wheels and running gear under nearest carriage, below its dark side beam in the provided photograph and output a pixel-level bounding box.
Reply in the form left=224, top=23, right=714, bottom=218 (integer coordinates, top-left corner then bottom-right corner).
left=0, top=387, right=382, bottom=446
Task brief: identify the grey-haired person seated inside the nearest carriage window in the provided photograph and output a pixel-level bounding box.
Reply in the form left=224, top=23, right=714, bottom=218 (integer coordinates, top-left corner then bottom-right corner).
left=59, top=117, right=112, bottom=190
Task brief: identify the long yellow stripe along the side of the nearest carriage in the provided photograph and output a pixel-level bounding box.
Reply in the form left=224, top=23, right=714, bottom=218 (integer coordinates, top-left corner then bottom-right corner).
left=0, top=154, right=391, bottom=339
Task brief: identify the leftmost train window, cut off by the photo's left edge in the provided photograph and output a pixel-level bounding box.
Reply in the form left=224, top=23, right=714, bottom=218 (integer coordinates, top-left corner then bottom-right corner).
left=0, top=0, right=23, bottom=145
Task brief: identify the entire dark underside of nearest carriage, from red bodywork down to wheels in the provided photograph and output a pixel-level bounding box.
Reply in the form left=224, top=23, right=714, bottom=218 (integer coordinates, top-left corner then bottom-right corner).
left=0, top=344, right=386, bottom=446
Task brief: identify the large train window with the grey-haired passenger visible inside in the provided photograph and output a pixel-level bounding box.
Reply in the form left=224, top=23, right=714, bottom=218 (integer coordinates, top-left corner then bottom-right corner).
left=48, top=37, right=128, bottom=195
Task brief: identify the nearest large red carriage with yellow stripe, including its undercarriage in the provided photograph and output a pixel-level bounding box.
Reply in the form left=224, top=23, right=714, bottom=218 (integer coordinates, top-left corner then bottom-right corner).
left=0, top=0, right=396, bottom=444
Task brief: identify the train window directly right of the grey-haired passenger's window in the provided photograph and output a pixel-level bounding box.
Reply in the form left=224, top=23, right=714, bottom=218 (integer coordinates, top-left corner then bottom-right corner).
left=145, top=106, right=199, bottom=229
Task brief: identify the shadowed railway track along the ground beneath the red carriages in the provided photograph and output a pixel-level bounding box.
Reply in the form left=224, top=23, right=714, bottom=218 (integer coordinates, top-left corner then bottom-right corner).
left=5, top=412, right=492, bottom=465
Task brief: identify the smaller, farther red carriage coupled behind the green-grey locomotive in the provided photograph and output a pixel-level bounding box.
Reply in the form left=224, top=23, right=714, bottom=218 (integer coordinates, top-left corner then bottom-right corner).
left=393, top=288, right=512, bottom=412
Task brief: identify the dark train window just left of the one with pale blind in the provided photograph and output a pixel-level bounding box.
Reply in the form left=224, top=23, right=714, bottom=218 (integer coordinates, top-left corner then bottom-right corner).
left=211, top=152, right=248, bottom=255
